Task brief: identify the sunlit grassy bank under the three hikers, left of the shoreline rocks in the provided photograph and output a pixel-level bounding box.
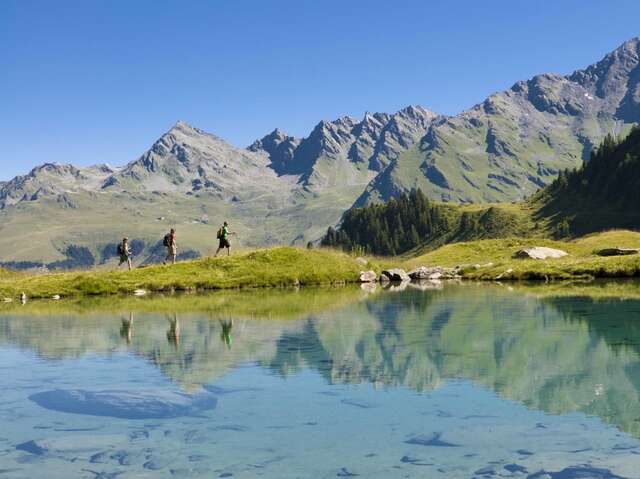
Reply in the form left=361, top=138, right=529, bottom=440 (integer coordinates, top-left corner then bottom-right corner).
left=0, top=247, right=375, bottom=298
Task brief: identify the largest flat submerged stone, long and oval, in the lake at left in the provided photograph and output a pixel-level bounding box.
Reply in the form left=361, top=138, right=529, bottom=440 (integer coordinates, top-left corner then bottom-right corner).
left=29, top=389, right=217, bottom=419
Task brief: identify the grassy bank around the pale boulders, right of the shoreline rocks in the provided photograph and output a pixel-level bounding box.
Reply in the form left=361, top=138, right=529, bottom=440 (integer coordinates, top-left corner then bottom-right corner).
left=404, top=230, right=640, bottom=280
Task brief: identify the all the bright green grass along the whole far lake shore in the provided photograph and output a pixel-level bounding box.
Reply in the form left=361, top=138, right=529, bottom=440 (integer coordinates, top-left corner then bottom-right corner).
left=5, top=230, right=640, bottom=302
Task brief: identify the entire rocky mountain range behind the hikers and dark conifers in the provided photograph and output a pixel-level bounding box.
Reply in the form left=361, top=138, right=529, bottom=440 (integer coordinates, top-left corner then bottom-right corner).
left=0, top=38, right=640, bottom=264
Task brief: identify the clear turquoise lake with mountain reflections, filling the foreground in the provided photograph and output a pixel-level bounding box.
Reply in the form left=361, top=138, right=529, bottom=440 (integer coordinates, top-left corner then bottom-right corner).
left=0, top=285, right=640, bottom=479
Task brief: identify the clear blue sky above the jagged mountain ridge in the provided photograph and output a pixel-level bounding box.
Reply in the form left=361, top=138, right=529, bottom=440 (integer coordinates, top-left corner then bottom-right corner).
left=0, top=0, right=640, bottom=180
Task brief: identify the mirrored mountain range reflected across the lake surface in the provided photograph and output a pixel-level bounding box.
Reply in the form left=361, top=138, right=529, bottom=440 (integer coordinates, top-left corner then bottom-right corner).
left=0, top=285, right=640, bottom=436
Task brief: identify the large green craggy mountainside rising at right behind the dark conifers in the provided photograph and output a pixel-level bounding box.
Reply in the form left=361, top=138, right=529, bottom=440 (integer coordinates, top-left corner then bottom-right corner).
left=357, top=38, right=640, bottom=205
